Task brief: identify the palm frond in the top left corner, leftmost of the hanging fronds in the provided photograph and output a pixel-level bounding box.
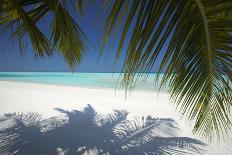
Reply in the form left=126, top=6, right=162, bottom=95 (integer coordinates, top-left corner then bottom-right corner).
left=0, top=0, right=51, bottom=56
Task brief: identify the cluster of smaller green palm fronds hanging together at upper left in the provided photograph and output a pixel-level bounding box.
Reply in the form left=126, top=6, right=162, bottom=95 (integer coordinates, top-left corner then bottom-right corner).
left=0, top=0, right=86, bottom=68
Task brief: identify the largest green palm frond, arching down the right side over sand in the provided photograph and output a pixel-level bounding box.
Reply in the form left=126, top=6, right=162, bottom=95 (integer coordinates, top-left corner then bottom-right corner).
left=102, top=0, right=232, bottom=140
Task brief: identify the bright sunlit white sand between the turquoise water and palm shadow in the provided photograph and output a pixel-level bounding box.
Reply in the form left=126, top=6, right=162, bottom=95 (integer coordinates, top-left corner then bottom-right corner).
left=0, top=81, right=232, bottom=155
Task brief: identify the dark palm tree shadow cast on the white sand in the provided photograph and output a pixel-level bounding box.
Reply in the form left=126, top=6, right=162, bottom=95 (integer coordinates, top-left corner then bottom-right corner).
left=0, top=105, right=205, bottom=155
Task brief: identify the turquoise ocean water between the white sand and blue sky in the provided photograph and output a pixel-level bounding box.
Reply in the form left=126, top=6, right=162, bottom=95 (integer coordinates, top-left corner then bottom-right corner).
left=0, top=72, right=166, bottom=91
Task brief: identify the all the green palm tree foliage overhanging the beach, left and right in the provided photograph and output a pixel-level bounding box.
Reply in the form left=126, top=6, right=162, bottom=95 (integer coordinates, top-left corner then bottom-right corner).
left=0, top=0, right=232, bottom=140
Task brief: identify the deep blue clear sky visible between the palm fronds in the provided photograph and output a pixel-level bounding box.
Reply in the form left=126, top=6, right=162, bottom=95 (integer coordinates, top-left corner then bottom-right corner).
left=0, top=1, right=165, bottom=72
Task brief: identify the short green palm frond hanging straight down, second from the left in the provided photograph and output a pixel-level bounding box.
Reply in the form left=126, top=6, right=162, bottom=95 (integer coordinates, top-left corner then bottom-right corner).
left=51, top=0, right=86, bottom=68
